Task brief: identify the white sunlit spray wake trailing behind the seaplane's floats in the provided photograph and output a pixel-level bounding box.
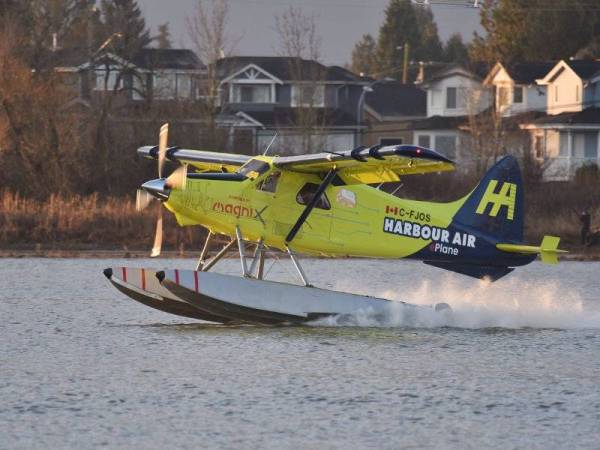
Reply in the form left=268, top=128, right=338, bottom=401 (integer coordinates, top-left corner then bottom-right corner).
left=312, top=278, right=600, bottom=329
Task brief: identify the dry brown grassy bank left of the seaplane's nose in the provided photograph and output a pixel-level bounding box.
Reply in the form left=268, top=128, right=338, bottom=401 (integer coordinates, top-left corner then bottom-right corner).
left=0, top=192, right=204, bottom=252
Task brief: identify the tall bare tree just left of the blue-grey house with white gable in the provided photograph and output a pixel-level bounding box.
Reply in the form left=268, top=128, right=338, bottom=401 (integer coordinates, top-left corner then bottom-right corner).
left=187, top=0, right=236, bottom=147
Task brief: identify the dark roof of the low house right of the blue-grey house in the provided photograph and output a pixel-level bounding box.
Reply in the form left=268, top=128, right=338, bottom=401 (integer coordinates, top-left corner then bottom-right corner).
left=365, top=81, right=427, bottom=117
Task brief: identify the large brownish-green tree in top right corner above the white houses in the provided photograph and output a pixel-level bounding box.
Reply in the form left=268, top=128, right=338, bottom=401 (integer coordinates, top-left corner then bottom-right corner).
left=470, top=0, right=600, bottom=64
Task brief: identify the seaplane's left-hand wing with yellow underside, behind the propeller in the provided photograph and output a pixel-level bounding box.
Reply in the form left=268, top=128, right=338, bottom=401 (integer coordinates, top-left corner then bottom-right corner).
left=137, top=145, right=250, bottom=172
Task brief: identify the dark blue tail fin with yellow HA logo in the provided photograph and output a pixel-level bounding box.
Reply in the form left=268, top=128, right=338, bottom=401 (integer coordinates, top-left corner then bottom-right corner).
left=454, top=156, right=523, bottom=242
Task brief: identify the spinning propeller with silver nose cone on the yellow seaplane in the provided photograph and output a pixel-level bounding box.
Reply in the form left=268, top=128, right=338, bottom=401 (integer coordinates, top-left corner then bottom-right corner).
left=135, top=123, right=187, bottom=258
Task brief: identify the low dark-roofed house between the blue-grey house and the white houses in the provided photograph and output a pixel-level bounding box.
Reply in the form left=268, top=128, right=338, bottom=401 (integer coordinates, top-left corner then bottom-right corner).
left=362, top=80, right=427, bottom=146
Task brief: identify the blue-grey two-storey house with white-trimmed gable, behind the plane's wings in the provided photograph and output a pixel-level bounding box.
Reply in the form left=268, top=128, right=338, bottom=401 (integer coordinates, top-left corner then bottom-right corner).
left=217, top=56, right=369, bottom=154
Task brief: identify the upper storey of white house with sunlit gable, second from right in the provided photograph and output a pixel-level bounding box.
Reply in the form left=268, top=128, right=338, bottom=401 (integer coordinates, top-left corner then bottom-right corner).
left=483, top=62, right=556, bottom=116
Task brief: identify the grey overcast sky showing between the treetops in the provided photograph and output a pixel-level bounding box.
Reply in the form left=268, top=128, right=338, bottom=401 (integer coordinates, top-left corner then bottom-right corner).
left=138, top=0, right=480, bottom=65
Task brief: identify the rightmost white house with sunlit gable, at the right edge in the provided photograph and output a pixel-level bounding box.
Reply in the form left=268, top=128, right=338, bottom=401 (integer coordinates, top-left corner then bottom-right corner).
left=520, top=60, right=600, bottom=181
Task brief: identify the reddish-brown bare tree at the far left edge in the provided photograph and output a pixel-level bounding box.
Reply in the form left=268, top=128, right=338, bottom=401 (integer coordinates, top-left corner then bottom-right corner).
left=0, top=19, right=80, bottom=197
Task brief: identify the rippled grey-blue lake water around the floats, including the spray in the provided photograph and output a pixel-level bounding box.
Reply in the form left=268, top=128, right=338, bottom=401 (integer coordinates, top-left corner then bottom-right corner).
left=0, top=258, right=600, bottom=449
